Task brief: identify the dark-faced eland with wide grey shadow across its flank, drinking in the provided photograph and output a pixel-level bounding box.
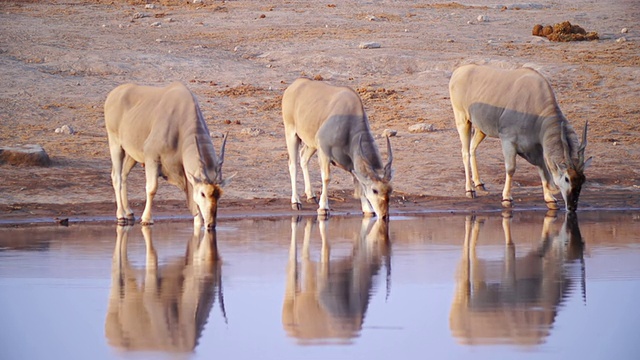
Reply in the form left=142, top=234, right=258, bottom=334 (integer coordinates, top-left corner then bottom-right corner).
left=449, top=65, right=591, bottom=211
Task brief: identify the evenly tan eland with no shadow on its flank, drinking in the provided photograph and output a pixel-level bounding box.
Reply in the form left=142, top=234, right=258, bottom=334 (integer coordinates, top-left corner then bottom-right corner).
left=104, top=83, right=230, bottom=229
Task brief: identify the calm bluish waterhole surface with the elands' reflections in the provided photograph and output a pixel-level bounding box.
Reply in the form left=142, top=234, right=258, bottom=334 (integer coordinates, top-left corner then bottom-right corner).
left=0, top=212, right=640, bottom=359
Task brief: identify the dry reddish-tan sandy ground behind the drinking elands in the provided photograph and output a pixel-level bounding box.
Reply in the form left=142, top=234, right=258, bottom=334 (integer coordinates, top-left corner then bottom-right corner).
left=0, top=0, right=640, bottom=223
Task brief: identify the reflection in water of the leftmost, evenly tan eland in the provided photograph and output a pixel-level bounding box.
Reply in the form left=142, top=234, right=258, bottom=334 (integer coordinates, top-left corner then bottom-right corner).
left=105, top=226, right=226, bottom=352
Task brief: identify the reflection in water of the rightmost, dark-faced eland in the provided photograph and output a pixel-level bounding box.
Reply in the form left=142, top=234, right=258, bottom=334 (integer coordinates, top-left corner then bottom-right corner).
left=449, top=213, right=585, bottom=345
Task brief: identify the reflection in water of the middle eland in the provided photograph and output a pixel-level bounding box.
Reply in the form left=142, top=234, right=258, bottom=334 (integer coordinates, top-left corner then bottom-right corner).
left=282, top=217, right=390, bottom=344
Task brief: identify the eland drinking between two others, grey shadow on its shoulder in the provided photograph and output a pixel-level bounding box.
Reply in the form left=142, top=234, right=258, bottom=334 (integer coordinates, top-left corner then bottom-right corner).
left=282, top=78, right=393, bottom=219
